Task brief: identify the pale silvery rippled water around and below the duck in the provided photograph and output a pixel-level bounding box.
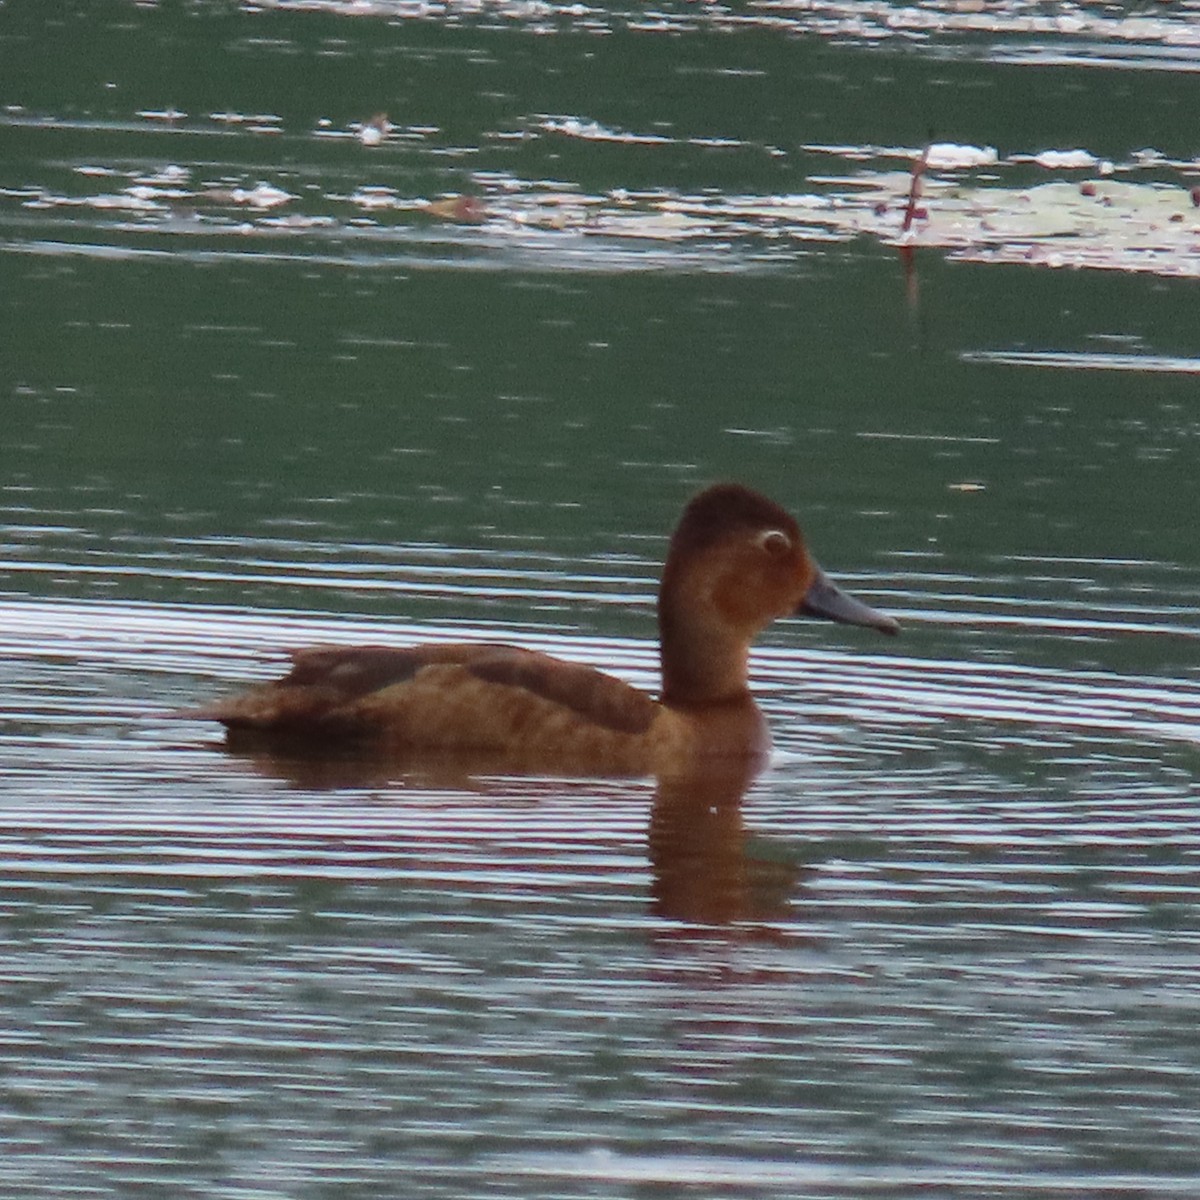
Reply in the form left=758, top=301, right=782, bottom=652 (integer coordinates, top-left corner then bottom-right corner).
left=0, top=580, right=1200, bottom=1195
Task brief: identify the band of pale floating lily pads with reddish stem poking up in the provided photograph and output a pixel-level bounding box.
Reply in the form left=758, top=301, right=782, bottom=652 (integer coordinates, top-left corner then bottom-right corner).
left=9, top=112, right=1200, bottom=276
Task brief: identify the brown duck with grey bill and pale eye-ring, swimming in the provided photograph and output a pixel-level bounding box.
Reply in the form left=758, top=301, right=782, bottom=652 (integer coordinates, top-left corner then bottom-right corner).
left=187, top=482, right=900, bottom=776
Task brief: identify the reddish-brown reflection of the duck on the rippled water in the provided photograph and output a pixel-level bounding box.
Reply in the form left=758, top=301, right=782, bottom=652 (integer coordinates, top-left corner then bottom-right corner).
left=224, top=736, right=810, bottom=935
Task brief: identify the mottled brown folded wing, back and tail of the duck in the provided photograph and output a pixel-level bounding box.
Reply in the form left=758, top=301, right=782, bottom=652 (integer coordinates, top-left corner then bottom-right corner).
left=181, top=643, right=659, bottom=742
